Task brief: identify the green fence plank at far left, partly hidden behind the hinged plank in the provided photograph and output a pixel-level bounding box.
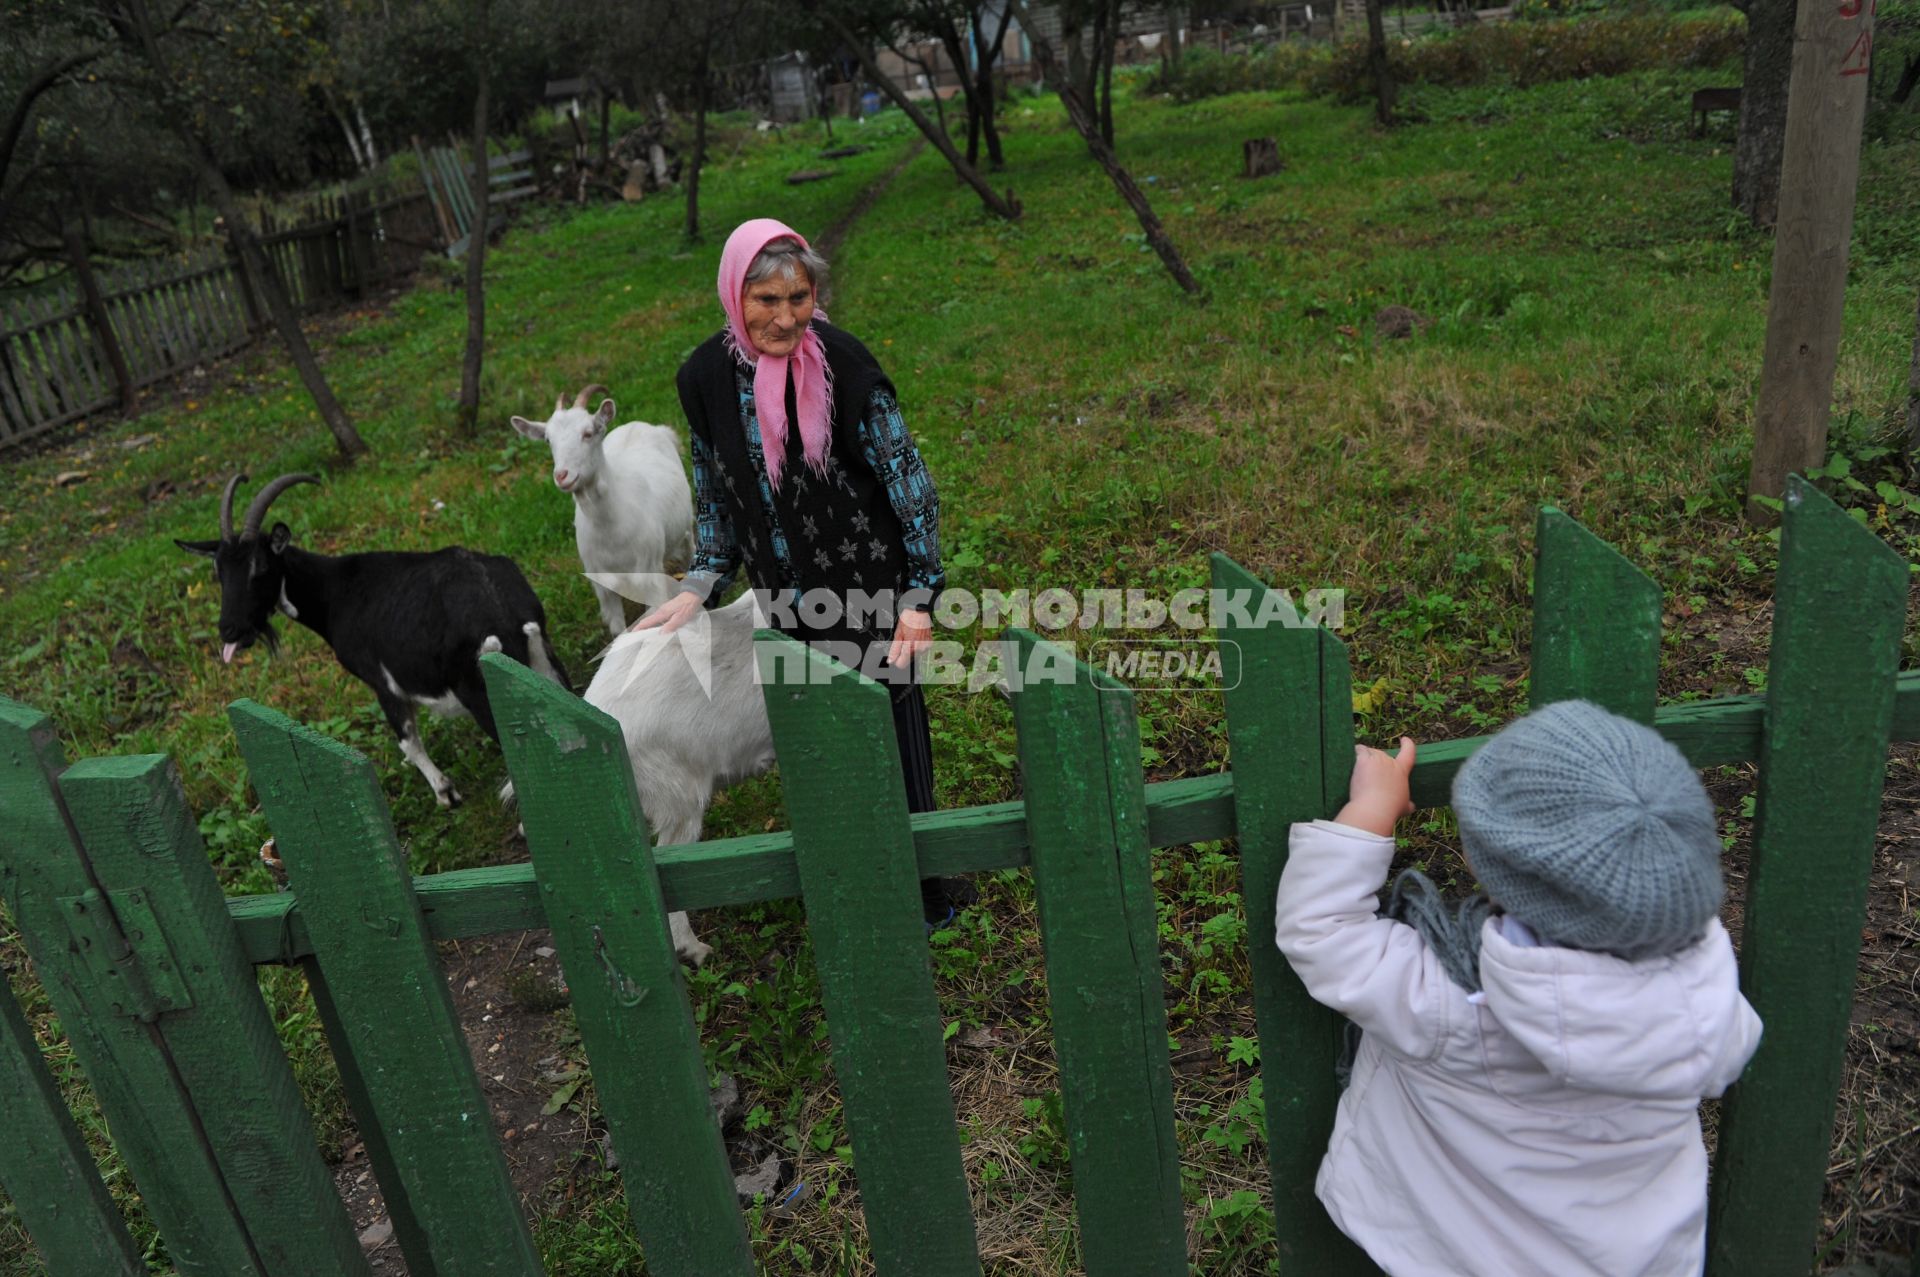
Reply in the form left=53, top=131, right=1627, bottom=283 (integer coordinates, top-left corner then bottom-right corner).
left=0, top=697, right=263, bottom=1277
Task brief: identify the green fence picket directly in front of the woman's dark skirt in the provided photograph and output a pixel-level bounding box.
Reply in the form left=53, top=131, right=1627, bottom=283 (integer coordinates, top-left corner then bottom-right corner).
left=756, top=630, right=981, bottom=1277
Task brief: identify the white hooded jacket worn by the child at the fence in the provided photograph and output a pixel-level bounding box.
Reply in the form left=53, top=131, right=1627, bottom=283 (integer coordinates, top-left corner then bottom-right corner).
left=1275, top=820, right=1761, bottom=1277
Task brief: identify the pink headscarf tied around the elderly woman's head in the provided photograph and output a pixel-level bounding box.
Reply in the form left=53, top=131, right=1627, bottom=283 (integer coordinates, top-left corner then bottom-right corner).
left=720, top=217, right=833, bottom=488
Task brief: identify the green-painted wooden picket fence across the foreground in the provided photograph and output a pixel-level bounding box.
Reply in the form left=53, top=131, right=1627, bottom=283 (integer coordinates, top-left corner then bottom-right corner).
left=0, top=480, right=1920, bottom=1277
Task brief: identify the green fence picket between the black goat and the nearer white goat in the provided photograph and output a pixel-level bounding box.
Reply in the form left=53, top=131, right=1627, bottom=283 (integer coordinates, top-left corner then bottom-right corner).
left=480, top=655, right=755, bottom=1277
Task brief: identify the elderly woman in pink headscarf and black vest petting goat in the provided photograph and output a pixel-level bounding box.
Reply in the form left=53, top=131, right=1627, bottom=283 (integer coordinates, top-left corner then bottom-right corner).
left=634, top=217, right=970, bottom=922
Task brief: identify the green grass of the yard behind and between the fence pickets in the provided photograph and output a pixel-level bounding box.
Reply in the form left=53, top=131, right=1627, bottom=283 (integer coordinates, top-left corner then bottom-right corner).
left=0, top=67, right=1920, bottom=1273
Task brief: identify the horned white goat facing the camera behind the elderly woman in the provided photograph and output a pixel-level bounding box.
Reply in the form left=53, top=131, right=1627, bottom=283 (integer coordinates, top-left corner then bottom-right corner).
left=513, top=386, right=693, bottom=636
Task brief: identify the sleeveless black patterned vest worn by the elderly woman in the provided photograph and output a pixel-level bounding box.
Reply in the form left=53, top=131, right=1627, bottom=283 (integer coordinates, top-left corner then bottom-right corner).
left=676, top=319, right=913, bottom=639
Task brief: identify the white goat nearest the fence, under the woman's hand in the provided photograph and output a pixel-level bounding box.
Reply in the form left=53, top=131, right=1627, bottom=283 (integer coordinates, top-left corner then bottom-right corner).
left=586, top=593, right=774, bottom=964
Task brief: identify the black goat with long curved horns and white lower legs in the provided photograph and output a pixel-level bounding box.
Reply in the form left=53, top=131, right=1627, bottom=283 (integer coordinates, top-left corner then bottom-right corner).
left=175, top=474, right=570, bottom=807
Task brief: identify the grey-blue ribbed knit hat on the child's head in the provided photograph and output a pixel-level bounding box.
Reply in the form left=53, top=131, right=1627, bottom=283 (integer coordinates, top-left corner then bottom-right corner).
left=1453, top=701, right=1724, bottom=958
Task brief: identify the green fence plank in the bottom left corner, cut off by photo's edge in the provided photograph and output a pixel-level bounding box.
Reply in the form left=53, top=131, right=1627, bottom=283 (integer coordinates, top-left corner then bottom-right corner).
left=0, top=976, right=146, bottom=1277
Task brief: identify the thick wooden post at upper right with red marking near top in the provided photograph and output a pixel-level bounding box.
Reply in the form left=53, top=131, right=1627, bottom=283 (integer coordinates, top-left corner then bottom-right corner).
left=1747, top=0, right=1878, bottom=524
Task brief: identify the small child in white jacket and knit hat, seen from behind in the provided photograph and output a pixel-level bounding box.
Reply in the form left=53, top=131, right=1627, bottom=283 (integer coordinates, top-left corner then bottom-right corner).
left=1277, top=701, right=1761, bottom=1277
